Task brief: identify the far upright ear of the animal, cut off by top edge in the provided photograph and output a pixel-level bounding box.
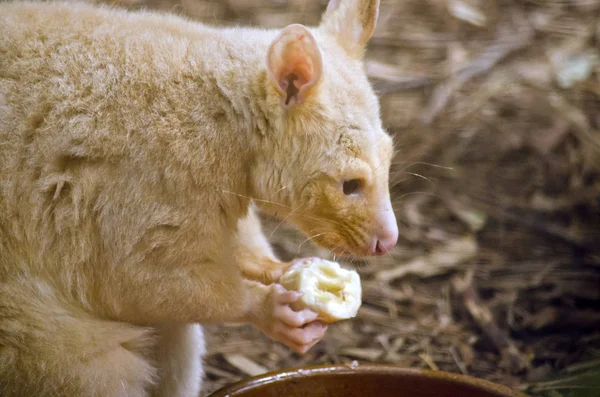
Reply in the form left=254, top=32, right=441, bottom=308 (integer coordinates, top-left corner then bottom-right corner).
left=321, top=0, right=379, bottom=58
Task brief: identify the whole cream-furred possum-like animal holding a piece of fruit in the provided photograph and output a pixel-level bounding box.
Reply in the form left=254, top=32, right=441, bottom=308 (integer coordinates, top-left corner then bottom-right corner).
left=0, top=0, right=397, bottom=397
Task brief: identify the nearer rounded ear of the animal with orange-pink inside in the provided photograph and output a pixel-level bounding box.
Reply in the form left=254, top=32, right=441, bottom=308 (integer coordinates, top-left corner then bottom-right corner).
left=267, top=24, right=323, bottom=106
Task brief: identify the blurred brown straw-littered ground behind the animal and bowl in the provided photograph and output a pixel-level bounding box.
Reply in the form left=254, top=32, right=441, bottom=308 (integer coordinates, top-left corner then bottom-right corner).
left=105, top=0, right=600, bottom=397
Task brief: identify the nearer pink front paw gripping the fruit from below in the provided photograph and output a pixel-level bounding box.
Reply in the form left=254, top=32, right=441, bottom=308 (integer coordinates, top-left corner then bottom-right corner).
left=258, top=284, right=327, bottom=353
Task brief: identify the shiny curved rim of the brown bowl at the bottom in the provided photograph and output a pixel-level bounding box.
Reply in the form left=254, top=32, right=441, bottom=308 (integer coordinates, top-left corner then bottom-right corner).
left=208, top=361, right=527, bottom=397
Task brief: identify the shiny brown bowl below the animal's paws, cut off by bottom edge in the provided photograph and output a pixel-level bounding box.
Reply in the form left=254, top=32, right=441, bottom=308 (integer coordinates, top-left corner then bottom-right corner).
left=210, top=363, right=525, bottom=397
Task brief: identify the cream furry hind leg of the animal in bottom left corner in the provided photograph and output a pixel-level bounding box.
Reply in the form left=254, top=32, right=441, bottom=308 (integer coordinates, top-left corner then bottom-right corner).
left=0, top=280, right=155, bottom=397
